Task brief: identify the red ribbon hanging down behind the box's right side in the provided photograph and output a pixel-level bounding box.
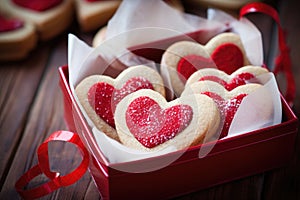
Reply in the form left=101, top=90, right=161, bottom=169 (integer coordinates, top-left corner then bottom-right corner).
left=240, top=2, right=296, bottom=106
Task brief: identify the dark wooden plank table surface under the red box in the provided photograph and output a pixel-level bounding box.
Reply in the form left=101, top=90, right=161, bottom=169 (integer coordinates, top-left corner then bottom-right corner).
left=0, top=0, right=300, bottom=199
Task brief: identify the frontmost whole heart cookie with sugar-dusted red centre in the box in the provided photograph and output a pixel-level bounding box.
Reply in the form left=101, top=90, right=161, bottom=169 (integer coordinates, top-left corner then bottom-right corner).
left=115, top=89, right=220, bottom=151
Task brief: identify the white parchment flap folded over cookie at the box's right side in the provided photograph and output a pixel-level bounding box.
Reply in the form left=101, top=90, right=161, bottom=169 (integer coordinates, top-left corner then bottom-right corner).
left=227, top=72, right=282, bottom=137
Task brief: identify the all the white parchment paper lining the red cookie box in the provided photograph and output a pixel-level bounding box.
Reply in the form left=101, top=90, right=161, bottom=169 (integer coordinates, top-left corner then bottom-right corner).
left=68, top=0, right=281, bottom=163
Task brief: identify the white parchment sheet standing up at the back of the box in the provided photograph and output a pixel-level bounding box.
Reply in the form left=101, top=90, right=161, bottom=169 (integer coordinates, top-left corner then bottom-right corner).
left=106, top=0, right=227, bottom=52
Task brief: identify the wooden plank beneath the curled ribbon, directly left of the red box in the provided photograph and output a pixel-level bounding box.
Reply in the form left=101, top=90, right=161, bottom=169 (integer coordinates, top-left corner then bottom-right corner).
left=0, top=35, right=99, bottom=199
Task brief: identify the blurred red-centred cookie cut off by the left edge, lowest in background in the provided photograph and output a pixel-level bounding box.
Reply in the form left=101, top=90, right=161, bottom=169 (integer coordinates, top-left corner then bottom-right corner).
left=0, top=13, right=37, bottom=61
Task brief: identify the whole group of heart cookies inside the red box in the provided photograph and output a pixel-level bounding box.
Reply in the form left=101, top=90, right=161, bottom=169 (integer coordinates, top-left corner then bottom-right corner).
left=75, top=33, right=272, bottom=151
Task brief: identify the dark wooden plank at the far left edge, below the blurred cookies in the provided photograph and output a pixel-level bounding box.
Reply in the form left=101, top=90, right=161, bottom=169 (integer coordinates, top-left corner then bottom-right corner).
left=0, top=45, right=50, bottom=188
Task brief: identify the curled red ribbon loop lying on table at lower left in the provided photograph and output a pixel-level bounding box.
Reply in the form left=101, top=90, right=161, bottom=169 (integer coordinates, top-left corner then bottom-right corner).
left=15, top=131, right=89, bottom=199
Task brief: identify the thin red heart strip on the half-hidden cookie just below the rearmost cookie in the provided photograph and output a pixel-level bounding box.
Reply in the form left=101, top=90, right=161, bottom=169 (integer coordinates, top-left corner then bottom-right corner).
left=199, top=72, right=255, bottom=91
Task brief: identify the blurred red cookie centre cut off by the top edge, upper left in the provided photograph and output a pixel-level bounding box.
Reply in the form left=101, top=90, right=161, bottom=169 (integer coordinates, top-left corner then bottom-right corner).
left=12, top=0, right=63, bottom=12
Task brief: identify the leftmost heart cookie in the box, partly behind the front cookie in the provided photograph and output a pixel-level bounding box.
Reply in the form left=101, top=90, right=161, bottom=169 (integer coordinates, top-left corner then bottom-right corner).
left=75, top=65, right=165, bottom=140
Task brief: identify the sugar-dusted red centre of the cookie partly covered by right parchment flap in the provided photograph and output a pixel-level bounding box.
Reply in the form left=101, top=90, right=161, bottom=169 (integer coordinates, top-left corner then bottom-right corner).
left=202, top=92, right=247, bottom=138
